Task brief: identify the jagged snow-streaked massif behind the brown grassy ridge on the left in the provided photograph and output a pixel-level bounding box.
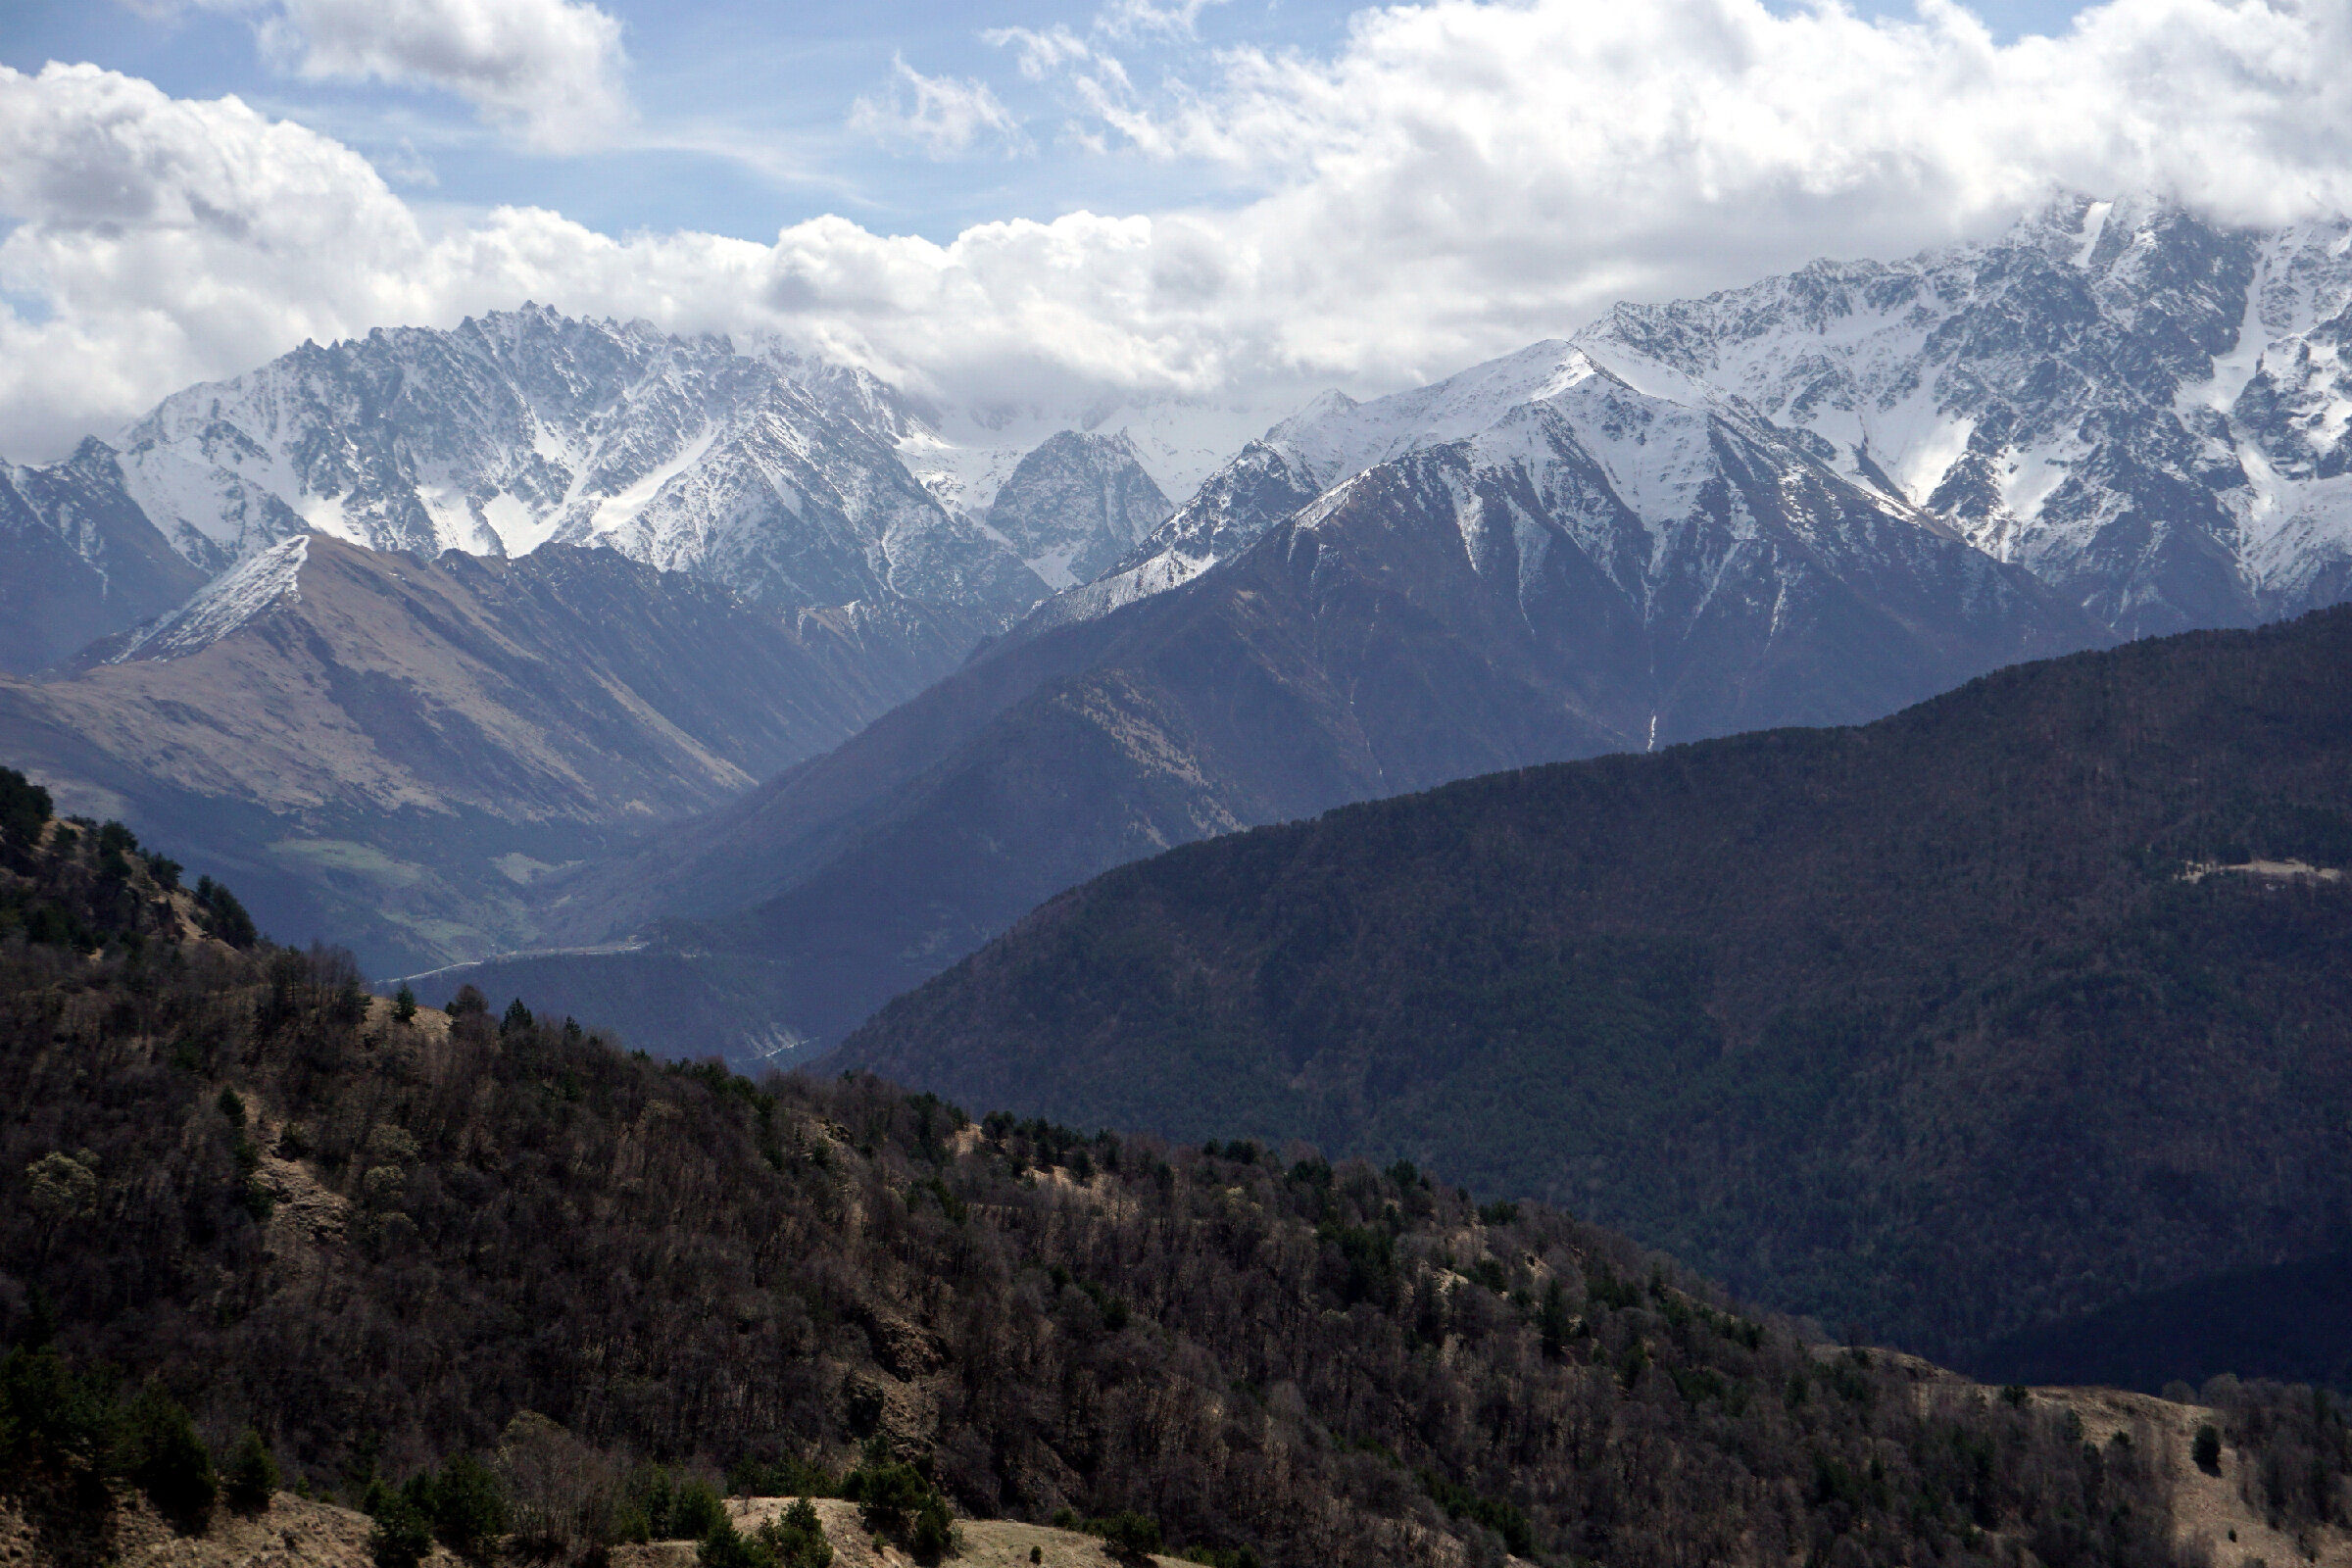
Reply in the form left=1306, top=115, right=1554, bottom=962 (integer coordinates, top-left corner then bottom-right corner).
left=122, top=308, right=1045, bottom=613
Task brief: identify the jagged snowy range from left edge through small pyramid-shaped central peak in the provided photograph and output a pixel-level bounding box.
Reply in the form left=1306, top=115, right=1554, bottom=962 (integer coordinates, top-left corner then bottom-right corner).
left=0, top=306, right=1203, bottom=672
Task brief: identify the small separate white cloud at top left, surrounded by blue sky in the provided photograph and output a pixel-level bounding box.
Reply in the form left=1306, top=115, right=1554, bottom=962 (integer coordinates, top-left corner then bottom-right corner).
left=260, top=0, right=628, bottom=153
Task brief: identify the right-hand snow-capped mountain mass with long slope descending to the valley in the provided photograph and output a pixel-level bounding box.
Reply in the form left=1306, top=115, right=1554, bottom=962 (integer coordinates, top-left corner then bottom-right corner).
left=437, top=200, right=2352, bottom=1044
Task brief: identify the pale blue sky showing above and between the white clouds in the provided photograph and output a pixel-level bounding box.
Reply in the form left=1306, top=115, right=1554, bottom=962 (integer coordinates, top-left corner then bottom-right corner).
left=0, top=0, right=2077, bottom=240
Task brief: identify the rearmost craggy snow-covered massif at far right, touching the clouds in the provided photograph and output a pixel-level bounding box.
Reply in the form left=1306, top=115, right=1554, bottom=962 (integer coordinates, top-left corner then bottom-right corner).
left=1576, top=200, right=2352, bottom=635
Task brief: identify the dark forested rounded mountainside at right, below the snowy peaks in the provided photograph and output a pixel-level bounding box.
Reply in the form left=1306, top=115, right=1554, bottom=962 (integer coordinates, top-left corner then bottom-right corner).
left=835, top=609, right=2352, bottom=1371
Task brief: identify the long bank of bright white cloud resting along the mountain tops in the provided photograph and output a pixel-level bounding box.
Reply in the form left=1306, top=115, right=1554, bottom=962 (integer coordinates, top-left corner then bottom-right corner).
left=0, top=0, right=2352, bottom=456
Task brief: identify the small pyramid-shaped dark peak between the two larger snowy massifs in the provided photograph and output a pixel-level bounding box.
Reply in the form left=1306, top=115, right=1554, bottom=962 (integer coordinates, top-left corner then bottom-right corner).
left=988, top=430, right=1174, bottom=588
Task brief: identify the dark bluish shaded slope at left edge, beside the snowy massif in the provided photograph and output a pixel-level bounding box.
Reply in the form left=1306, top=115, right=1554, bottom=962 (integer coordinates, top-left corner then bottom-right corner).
left=0, top=442, right=205, bottom=674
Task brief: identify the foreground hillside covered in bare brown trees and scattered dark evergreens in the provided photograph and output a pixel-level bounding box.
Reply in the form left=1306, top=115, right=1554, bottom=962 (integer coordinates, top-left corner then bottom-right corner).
left=0, top=788, right=2347, bottom=1568
